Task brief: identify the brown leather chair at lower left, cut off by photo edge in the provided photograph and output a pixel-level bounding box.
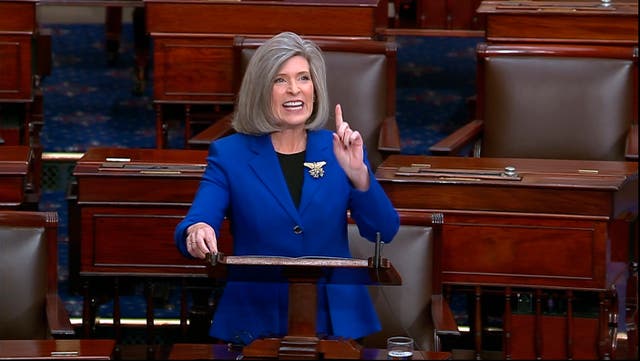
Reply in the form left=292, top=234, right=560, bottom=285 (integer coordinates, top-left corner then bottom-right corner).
left=0, top=210, right=74, bottom=339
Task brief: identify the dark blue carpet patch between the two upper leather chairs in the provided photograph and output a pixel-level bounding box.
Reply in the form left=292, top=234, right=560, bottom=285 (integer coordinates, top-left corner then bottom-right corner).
left=396, top=36, right=482, bottom=154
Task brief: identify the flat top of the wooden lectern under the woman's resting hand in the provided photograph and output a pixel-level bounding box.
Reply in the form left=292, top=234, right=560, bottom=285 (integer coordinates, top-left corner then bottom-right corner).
left=206, top=252, right=402, bottom=285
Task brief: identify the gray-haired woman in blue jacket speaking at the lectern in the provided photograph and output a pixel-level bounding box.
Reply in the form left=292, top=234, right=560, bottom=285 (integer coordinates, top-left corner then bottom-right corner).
left=175, top=32, right=399, bottom=344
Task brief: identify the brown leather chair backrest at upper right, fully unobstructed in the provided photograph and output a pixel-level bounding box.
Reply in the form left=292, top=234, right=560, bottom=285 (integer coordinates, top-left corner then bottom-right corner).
left=477, top=43, right=638, bottom=160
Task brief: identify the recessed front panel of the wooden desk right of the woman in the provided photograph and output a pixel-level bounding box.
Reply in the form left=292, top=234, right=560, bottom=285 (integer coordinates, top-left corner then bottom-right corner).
left=440, top=214, right=608, bottom=290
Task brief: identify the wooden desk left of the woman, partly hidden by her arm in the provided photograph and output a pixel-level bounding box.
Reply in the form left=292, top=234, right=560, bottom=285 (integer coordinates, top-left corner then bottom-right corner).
left=69, top=148, right=232, bottom=352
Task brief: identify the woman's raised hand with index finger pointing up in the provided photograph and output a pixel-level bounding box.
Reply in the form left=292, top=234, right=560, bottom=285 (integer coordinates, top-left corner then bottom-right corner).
left=333, top=104, right=369, bottom=191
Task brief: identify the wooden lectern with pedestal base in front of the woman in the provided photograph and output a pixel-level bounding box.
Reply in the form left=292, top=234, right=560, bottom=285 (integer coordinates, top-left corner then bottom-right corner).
left=207, top=250, right=402, bottom=360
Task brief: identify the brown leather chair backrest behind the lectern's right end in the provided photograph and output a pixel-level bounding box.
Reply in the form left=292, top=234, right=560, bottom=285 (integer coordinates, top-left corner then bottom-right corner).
left=348, top=224, right=434, bottom=351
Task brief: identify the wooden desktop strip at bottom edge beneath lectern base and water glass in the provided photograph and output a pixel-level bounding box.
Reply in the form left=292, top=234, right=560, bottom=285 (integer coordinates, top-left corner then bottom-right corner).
left=169, top=343, right=451, bottom=360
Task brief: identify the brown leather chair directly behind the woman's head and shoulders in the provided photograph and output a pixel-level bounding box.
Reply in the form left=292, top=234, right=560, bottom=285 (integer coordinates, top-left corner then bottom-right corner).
left=187, top=37, right=400, bottom=168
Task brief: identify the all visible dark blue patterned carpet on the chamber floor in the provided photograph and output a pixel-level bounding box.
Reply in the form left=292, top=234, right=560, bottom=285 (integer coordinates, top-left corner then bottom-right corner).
left=40, top=23, right=482, bottom=317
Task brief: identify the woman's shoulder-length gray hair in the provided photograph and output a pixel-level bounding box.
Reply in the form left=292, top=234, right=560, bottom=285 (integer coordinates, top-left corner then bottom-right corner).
left=231, top=32, right=329, bottom=135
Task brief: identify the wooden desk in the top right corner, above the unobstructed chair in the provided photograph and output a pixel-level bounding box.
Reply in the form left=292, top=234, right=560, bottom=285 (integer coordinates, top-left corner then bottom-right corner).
left=477, top=0, right=638, bottom=46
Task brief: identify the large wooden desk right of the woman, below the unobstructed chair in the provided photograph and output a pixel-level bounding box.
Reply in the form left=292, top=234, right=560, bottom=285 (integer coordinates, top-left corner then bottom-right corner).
left=376, top=155, right=638, bottom=359
